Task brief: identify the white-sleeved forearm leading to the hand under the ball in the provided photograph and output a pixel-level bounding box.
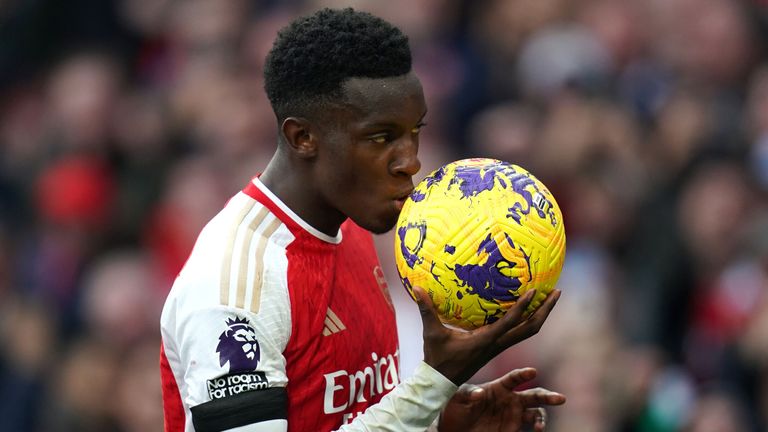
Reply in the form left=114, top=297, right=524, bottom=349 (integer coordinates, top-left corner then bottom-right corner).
left=338, top=363, right=457, bottom=432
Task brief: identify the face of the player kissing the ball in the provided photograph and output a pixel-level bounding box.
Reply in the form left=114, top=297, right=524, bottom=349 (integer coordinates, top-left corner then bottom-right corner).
left=314, top=73, right=427, bottom=233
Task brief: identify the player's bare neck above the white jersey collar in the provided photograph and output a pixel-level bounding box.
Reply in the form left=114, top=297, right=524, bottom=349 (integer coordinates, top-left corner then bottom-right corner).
left=259, top=151, right=346, bottom=237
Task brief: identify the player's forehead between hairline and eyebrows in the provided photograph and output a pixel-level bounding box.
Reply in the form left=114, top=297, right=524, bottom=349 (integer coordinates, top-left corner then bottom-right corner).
left=332, top=72, right=427, bottom=123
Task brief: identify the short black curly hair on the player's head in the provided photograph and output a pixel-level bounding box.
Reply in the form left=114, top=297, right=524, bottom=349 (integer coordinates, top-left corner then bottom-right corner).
left=264, top=8, right=411, bottom=121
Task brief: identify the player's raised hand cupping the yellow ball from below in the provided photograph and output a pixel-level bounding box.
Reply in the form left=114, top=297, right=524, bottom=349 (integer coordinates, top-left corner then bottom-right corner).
left=413, top=287, right=560, bottom=385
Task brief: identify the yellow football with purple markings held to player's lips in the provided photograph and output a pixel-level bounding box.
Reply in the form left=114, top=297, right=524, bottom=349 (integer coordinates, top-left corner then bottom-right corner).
left=395, top=158, right=565, bottom=329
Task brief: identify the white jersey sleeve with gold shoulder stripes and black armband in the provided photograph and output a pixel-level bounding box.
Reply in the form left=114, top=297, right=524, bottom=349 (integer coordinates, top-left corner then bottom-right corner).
left=161, top=194, right=291, bottom=432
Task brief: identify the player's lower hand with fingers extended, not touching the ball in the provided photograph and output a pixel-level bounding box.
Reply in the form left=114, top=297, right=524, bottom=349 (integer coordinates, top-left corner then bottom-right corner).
left=438, top=368, right=565, bottom=432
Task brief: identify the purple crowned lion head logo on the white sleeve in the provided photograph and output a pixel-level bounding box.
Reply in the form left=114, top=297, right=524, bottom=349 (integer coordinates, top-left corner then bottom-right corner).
left=216, top=318, right=261, bottom=372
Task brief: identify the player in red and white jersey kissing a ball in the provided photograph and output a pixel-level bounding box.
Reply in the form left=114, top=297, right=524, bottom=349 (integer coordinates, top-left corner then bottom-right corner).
left=161, top=9, right=564, bottom=432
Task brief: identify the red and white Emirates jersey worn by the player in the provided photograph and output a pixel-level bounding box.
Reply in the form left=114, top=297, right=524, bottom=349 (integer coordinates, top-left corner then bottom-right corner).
left=161, top=179, right=399, bottom=432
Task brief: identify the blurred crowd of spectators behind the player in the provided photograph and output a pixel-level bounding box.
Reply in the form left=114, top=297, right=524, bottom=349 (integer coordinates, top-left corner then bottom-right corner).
left=0, top=0, right=768, bottom=432
